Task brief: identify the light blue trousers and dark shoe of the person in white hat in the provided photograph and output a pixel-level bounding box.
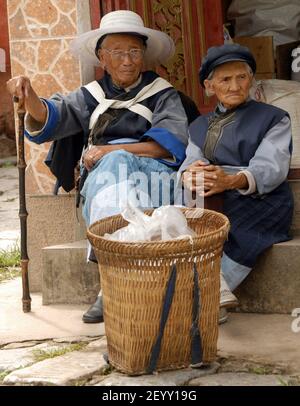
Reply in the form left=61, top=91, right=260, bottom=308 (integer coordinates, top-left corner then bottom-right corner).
left=81, top=150, right=174, bottom=323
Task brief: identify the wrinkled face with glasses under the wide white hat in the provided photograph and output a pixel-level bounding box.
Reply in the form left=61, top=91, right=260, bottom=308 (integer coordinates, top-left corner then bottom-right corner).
left=98, top=34, right=145, bottom=88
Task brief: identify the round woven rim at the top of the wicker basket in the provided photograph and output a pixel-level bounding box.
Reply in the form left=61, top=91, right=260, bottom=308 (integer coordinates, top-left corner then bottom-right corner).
left=87, top=208, right=230, bottom=249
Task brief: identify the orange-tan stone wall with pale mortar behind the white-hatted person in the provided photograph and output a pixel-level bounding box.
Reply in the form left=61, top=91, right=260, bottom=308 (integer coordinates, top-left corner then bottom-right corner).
left=7, top=0, right=89, bottom=194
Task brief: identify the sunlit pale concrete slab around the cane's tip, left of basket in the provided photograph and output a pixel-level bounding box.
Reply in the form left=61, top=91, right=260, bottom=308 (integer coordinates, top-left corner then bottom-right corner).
left=0, top=278, right=104, bottom=346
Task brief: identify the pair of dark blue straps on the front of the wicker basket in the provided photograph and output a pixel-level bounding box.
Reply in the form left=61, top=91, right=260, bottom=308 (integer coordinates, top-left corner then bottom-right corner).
left=147, top=264, right=202, bottom=374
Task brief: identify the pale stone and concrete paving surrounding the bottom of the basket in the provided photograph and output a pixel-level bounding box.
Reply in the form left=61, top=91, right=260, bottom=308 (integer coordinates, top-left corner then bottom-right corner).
left=0, top=278, right=300, bottom=386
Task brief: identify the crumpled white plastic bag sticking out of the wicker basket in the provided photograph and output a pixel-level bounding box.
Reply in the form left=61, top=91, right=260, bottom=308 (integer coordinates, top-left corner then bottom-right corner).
left=104, top=204, right=196, bottom=242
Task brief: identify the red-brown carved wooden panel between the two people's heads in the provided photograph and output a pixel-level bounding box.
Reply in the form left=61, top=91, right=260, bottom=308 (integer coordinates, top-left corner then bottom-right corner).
left=130, top=0, right=223, bottom=112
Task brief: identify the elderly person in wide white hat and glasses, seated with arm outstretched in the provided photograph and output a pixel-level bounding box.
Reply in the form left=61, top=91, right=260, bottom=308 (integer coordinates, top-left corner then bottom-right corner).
left=7, top=10, right=191, bottom=323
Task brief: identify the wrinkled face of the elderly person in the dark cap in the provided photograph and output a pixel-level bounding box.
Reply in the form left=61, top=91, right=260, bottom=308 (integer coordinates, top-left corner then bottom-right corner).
left=204, top=62, right=253, bottom=109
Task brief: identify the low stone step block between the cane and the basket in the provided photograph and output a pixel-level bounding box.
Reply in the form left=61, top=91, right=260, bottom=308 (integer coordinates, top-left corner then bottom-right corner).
left=42, top=240, right=100, bottom=305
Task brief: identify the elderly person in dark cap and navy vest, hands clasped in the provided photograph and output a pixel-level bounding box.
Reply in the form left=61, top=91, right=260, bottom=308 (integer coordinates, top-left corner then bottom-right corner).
left=180, top=44, right=293, bottom=321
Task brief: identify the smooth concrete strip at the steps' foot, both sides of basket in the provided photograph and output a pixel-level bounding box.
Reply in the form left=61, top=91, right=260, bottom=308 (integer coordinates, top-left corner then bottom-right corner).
left=0, top=278, right=300, bottom=368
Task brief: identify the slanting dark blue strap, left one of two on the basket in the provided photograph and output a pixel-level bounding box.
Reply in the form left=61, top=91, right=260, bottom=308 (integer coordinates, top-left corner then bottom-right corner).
left=147, top=265, right=177, bottom=374
